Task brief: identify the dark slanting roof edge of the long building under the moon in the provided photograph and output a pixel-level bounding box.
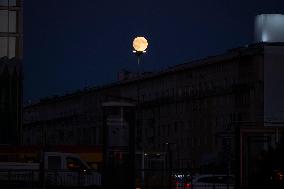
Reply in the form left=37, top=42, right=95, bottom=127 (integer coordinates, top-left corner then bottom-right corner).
left=25, top=42, right=284, bottom=107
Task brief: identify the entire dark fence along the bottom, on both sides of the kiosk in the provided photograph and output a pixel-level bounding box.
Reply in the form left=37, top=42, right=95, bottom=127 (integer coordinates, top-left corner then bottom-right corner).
left=0, top=169, right=235, bottom=189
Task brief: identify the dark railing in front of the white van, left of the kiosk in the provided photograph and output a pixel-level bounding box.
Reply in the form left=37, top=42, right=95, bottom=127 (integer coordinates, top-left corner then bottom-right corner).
left=0, top=170, right=101, bottom=189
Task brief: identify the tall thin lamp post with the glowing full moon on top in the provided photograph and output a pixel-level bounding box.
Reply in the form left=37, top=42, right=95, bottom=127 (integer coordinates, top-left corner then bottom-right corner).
left=133, top=37, right=148, bottom=187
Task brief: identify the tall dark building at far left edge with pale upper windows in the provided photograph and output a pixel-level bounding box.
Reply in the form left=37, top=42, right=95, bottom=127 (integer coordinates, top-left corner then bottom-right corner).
left=0, top=0, right=22, bottom=144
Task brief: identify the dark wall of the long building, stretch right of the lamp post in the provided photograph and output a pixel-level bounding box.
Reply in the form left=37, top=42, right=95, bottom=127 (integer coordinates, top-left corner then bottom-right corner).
left=129, top=49, right=262, bottom=168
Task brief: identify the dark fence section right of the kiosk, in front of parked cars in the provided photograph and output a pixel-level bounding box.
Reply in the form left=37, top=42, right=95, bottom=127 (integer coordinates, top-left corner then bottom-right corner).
left=136, top=169, right=235, bottom=189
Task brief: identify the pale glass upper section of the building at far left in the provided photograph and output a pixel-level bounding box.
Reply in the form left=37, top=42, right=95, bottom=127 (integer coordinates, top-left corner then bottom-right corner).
left=0, top=0, right=22, bottom=59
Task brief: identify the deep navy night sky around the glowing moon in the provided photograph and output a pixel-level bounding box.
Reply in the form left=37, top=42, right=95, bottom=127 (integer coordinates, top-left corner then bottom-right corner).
left=24, top=0, right=284, bottom=100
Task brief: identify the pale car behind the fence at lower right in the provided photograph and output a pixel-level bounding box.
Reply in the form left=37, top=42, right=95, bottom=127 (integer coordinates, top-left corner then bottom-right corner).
left=191, top=174, right=235, bottom=189
